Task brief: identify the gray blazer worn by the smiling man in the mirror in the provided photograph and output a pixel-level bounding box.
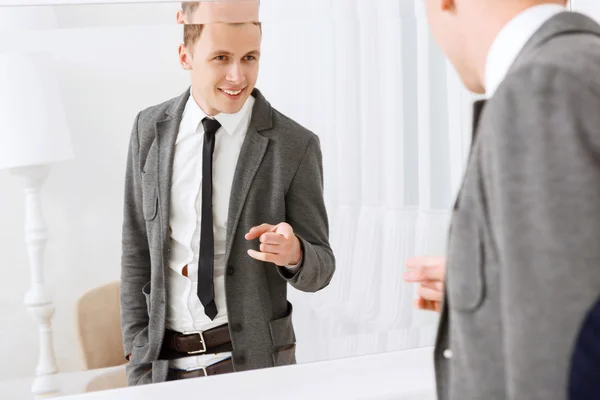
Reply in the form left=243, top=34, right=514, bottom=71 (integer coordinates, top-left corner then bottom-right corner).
left=121, top=89, right=335, bottom=385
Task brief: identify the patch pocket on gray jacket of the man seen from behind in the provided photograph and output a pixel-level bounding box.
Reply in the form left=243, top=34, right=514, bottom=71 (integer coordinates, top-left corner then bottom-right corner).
left=447, top=209, right=485, bottom=312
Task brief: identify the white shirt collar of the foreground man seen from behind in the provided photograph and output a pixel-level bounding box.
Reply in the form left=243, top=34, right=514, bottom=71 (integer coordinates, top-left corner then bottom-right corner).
left=485, top=4, right=566, bottom=98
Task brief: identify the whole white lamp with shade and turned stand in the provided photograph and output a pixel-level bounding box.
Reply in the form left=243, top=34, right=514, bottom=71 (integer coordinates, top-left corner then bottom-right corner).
left=0, top=54, right=73, bottom=397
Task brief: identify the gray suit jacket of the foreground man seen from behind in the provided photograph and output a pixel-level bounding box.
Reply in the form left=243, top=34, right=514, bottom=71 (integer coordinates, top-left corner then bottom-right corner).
left=435, top=13, right=600, bottom=400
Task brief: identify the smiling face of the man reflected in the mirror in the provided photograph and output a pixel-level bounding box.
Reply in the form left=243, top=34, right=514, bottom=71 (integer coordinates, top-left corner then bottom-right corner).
left=181, top=23, right=262, bottom=115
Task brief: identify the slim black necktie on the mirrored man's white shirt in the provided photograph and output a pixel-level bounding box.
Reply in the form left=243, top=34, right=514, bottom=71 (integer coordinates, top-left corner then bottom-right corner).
left=198, top=118, right=221, bottom=320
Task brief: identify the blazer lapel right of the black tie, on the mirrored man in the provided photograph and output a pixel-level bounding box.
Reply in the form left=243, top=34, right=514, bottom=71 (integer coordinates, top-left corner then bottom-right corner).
left=225, top=89, right=273, bottom=260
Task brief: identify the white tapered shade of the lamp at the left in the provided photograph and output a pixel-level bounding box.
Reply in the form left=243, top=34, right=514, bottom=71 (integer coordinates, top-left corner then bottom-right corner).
left=0, top=53, right=73, bottom=169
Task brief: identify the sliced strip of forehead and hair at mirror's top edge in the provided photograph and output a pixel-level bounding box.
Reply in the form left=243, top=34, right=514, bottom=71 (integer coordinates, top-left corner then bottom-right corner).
left=177, top=0, right=260, bottom=24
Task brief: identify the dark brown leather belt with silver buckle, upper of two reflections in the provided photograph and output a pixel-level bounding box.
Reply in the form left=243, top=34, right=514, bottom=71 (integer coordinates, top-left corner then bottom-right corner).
left=159, top=324, right=233, bottom=360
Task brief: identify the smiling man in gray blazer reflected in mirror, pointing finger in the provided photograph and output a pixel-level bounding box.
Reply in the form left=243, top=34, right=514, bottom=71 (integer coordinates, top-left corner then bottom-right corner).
left=121, top=2, right=335, bottom=385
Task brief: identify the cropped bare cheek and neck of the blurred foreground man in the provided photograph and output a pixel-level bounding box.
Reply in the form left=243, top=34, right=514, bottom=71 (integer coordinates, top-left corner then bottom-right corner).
left=423, top=0, right=567, bottom=93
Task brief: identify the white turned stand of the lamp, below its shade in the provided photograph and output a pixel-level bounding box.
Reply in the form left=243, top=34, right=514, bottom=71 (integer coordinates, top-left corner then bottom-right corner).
left=10, top=165, right=60, bottom=398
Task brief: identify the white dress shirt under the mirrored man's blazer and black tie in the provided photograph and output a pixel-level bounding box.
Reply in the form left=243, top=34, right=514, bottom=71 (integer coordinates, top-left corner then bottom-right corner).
left=166, top=94, right=255, bottom=370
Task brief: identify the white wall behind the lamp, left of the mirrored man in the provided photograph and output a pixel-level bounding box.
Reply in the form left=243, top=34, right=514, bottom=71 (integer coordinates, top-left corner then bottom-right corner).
left=0, top=5, right=187, bottom=378
